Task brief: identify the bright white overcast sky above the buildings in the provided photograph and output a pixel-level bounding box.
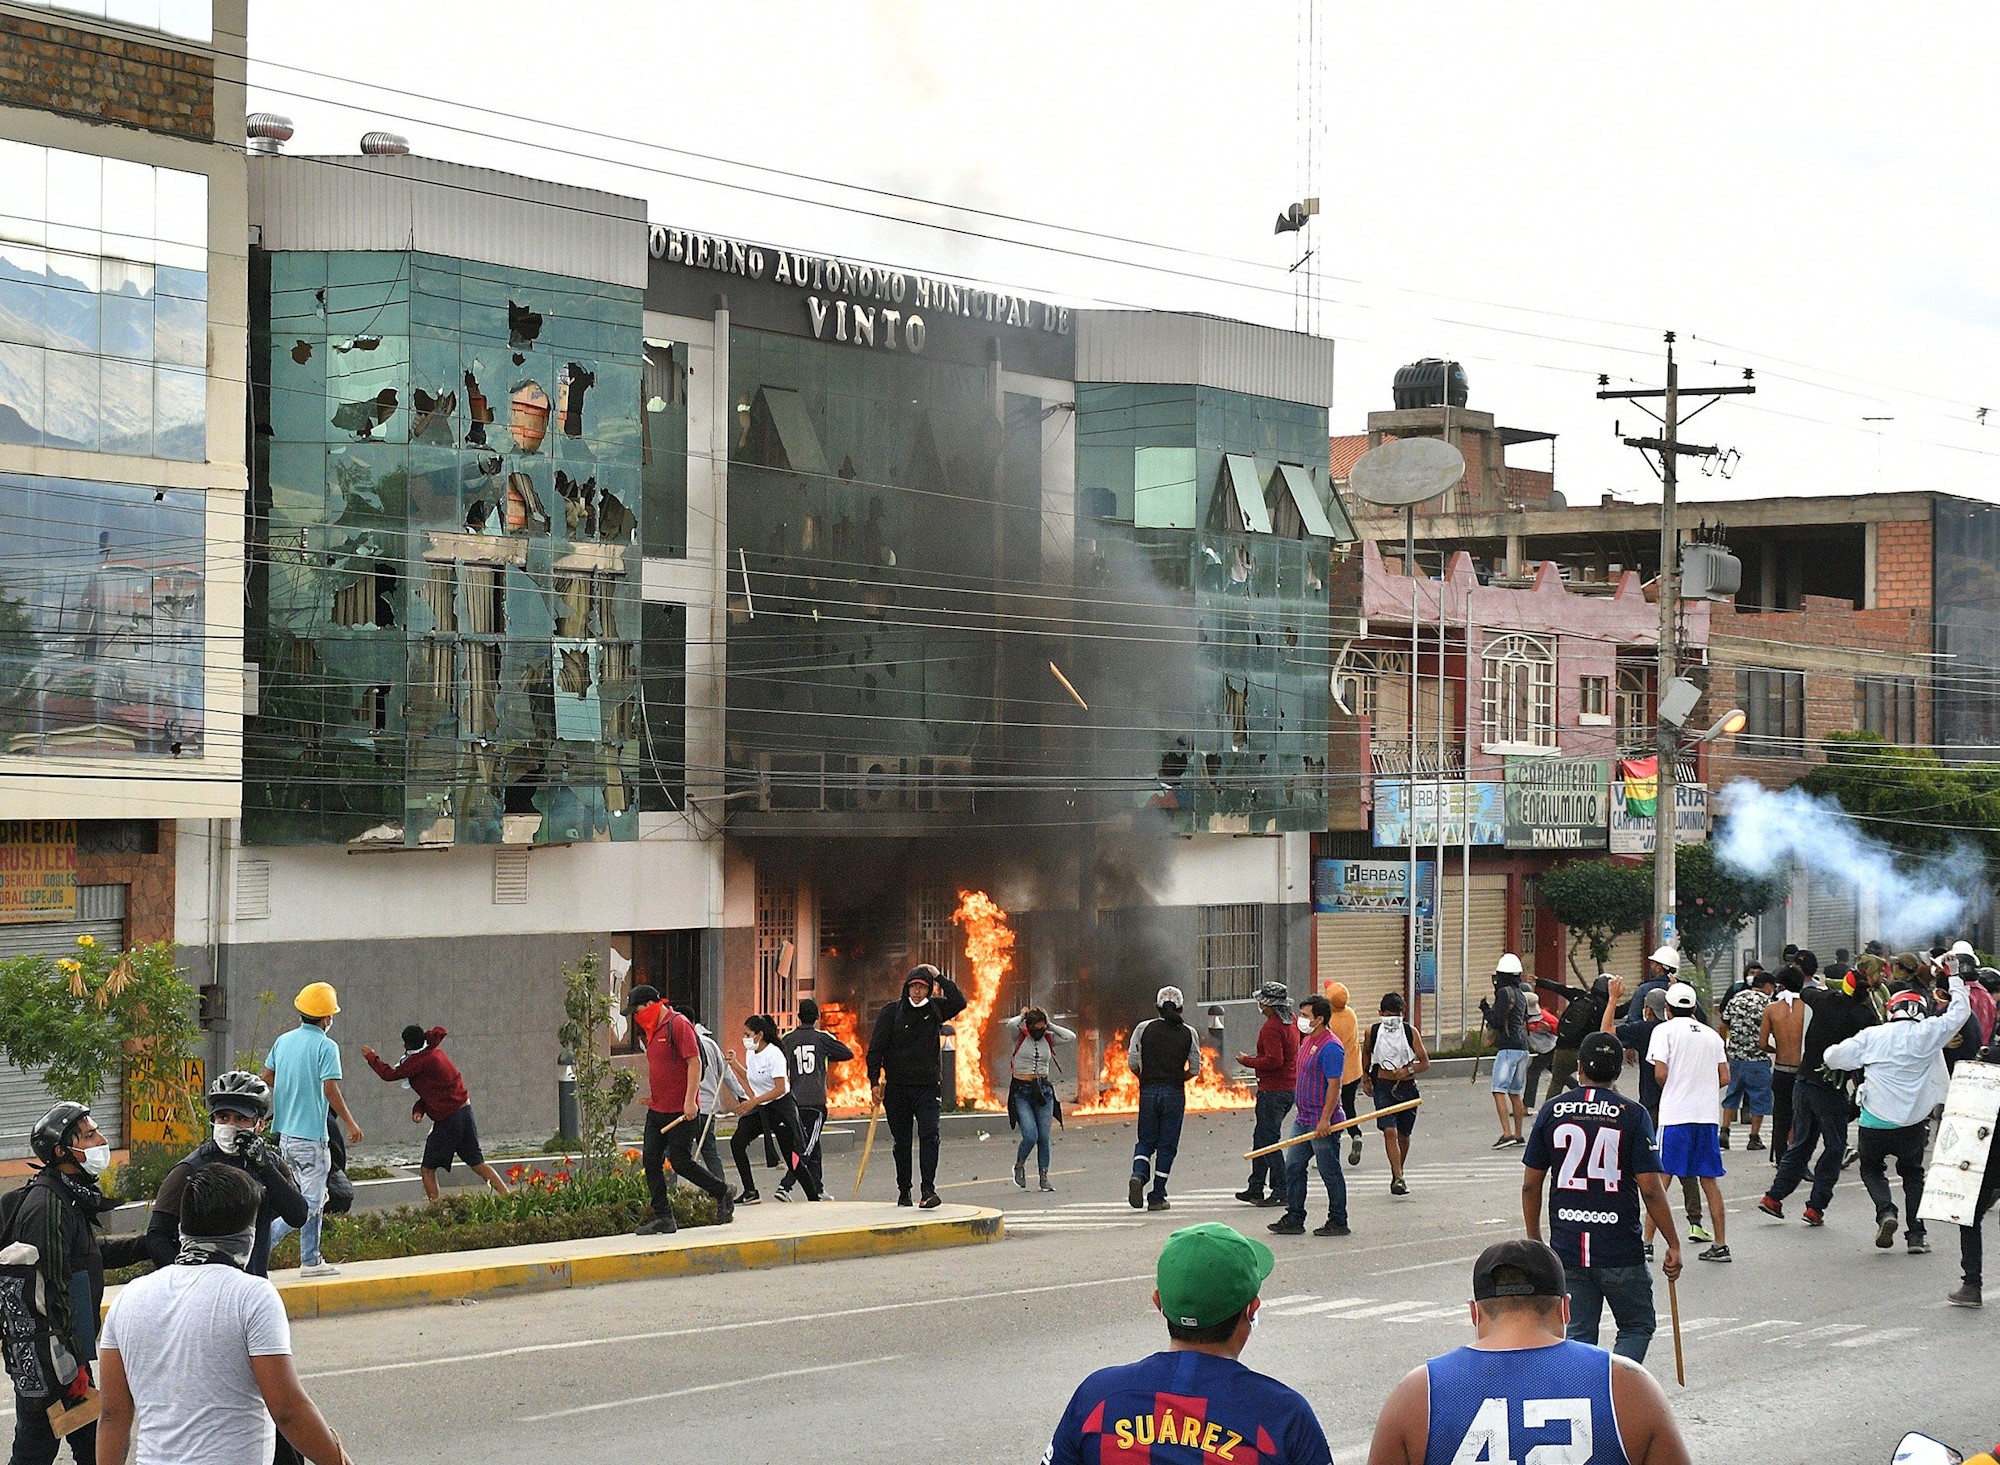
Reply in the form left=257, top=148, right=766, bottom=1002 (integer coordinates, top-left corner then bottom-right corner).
left=250, top=0, right=2000, bottom=502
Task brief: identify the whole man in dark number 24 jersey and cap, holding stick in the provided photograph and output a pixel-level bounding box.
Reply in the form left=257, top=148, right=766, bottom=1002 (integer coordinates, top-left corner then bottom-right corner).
left=1520, top=1033, right=1680, bottom=1363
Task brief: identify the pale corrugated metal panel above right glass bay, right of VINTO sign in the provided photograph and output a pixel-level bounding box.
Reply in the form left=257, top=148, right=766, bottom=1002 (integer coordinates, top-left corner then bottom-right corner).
left=1076, top=310, right=1334, bottom=406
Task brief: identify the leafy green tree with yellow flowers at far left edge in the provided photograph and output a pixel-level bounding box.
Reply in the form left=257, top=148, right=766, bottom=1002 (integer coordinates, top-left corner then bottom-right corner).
left=0, top=937, right=200, bottom=1117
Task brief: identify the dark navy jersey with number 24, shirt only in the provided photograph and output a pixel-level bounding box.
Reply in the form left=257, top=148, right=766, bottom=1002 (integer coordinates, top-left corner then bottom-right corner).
left=1520, top=1089, right=1660, bottom=1267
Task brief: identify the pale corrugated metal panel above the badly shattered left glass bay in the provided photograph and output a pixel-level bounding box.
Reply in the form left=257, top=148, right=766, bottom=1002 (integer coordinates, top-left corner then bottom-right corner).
left=250, top=156, right=646, bottom=290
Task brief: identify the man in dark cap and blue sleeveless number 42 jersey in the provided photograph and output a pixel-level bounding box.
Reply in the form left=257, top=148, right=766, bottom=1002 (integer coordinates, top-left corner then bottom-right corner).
left=1368, top=1241, right=1690, bottom=1465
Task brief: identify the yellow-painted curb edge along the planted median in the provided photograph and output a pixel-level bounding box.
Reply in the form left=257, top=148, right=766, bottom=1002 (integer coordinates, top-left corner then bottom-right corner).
left=266, top=1207, right=1006, bottom=1317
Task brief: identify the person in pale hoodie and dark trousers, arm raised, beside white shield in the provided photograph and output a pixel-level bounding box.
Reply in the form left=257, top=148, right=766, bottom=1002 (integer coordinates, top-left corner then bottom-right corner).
left=1822, top=975, right=1972, bottom=1257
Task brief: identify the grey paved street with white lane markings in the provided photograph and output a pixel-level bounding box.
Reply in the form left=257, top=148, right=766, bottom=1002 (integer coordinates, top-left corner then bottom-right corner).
left=270, top=1081, right=2000, bottom=1465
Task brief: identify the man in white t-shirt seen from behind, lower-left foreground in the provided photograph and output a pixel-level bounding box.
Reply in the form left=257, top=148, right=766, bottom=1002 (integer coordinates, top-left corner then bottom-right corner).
left=98, top=1165, right=352, bottom=1465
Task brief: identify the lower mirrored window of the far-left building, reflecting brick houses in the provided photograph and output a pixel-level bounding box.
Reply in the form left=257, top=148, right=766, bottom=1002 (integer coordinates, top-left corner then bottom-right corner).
left=0, top=474, right=208, bottom=757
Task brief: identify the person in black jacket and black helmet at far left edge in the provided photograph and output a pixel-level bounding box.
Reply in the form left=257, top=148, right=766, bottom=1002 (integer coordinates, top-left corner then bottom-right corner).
left=0, top=1103, right=148, bottom=1465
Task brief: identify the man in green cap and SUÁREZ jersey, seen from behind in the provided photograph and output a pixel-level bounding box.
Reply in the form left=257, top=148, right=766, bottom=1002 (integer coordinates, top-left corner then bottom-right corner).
left=1042, top=1223, right=1334, bottom=1465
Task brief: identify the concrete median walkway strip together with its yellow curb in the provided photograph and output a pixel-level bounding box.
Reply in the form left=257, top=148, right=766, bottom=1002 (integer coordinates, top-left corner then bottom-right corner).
left=193, top=1201, right=1004, bottom=1317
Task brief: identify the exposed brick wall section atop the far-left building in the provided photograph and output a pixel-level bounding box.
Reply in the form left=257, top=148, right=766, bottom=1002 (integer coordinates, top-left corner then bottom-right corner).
left=0, top=16, right=216, bottom=142
